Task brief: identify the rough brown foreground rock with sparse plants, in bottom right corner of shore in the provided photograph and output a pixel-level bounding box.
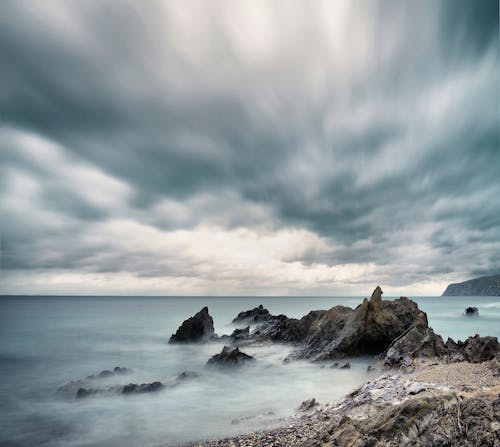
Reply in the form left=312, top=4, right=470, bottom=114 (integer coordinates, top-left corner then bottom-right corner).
left=316, top=390, right=500, bottom=447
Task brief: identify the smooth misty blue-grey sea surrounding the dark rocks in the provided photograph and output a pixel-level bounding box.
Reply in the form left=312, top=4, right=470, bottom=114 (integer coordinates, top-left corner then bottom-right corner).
left=0, top=296, right=500, bottom=447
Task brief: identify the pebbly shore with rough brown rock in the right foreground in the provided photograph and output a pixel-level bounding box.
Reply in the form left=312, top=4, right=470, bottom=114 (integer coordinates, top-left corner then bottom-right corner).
left=173, top=360, right=500, bottom=447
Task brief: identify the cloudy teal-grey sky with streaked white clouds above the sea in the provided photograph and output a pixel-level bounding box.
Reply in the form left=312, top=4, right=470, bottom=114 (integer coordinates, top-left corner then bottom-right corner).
left=0, top=0, right=500, bottom=296
